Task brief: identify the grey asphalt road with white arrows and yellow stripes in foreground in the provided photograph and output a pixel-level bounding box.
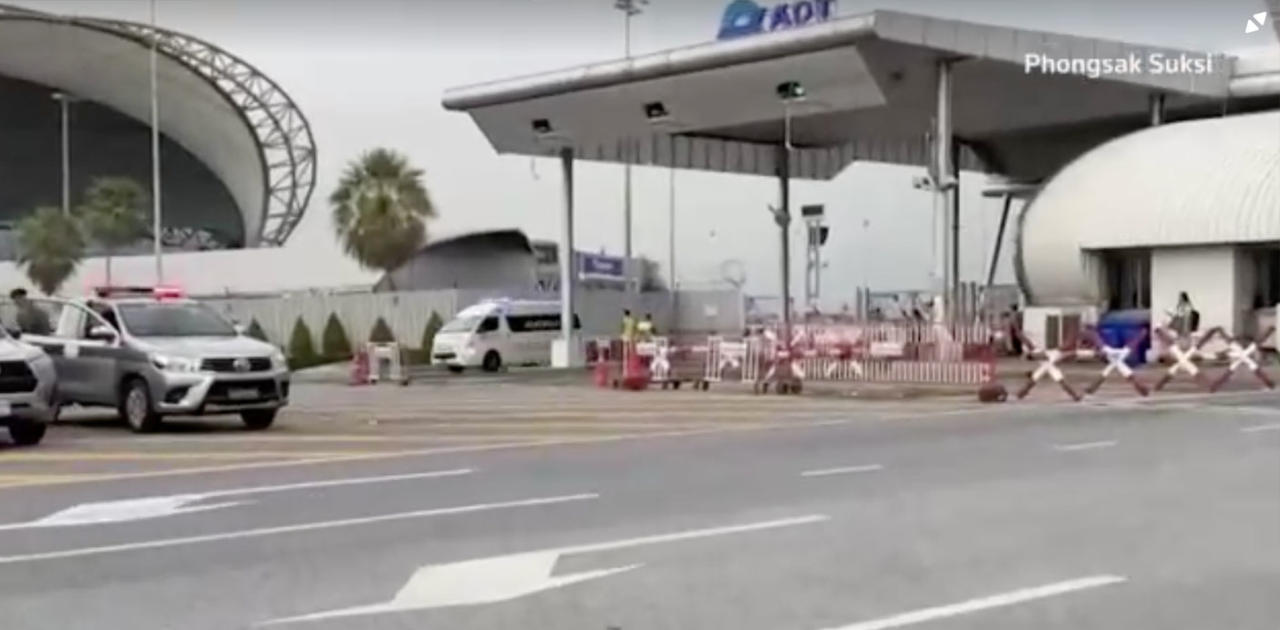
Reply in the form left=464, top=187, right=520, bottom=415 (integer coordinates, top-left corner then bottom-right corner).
left=0, top=388, right=1280, bottom=630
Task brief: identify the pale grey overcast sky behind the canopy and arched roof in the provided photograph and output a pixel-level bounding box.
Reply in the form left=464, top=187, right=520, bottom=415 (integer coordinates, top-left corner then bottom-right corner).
left=8, top=0, right=1270, bottom=303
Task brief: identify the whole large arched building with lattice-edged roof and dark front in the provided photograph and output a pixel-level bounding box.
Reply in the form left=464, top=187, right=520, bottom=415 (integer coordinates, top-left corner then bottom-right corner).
left=0, top=5, right=316, bottom=260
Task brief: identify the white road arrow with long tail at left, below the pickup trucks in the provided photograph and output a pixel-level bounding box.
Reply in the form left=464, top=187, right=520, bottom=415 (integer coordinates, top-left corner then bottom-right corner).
left=0, top=469, right=472, bottom=531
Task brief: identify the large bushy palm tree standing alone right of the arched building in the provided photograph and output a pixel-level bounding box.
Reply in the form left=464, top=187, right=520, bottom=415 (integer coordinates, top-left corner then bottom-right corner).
left=329, top=149, right=435, bottom=289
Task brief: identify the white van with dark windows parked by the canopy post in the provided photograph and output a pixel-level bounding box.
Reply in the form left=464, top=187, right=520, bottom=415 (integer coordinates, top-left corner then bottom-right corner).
left=431, top=300, right=582, bottom=373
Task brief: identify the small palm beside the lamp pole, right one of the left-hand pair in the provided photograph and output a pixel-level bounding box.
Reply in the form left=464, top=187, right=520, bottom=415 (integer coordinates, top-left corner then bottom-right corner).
left=78, top=177, right=147, bottom=286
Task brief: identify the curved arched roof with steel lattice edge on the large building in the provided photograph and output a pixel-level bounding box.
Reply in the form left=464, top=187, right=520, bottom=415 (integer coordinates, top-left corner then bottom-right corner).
left=0, top=5, right=316, bottom=247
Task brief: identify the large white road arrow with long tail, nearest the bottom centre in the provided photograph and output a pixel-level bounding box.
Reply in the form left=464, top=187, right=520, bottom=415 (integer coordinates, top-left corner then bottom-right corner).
left=259, top=515, right=828, bottom=626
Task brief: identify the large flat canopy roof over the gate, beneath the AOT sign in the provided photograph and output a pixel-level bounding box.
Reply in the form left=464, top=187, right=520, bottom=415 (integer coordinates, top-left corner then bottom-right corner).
left=444, top=10, right=1233, bottom=179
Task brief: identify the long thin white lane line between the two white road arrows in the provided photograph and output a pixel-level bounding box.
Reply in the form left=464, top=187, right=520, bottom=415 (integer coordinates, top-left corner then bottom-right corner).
left=0, top=494, right=600, bottom=565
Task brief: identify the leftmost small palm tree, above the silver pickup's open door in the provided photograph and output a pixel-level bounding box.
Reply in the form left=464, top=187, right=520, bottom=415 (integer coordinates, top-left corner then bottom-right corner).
left=18, top=207, right=84, bottom=296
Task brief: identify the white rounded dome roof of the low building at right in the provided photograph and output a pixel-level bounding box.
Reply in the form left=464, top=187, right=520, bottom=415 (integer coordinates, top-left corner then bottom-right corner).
left=1015, top=111, right=1280, bottom=305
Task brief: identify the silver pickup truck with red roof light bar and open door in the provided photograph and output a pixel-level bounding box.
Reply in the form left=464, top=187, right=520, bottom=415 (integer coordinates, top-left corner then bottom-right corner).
left=10, top=289, right=289, bottom=432
